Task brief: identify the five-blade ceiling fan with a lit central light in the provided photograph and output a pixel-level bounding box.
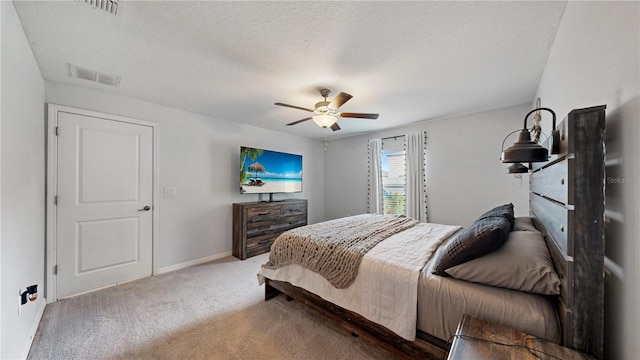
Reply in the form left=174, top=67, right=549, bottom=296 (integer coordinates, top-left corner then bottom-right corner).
left=274, top=89, right=379, bottom=131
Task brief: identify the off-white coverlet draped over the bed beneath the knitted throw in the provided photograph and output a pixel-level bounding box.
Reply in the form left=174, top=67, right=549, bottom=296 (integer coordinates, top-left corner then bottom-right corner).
left=258, top=223, right=461, bottom=341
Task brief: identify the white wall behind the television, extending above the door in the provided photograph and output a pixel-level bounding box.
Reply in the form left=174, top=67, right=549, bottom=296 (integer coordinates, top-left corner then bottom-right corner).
left=46, top=81, right=324, bottom=271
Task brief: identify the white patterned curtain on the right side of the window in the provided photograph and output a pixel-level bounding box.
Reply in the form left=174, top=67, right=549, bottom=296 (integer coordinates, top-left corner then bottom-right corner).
left=405, top=131, right=427, bottom=222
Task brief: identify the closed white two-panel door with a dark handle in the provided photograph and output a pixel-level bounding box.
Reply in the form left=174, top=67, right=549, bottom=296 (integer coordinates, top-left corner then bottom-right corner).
left=56, top=112, right=153, bottom=299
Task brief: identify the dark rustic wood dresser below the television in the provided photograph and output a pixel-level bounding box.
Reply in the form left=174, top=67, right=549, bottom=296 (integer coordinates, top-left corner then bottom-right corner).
left=231, top=199, right=307, bottom=260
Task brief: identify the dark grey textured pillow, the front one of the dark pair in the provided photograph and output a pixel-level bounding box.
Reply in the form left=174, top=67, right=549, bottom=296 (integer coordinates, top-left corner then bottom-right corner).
left=433, top=216, right=511, bottom=276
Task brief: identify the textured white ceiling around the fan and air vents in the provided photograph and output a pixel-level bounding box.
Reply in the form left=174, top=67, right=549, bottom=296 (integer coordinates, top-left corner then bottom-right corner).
left=14, top=0, right=566, bottom=139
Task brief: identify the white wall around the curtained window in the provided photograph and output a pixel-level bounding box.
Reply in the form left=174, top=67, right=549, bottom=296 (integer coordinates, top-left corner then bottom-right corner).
left=325, top=104, right=531, bottom=226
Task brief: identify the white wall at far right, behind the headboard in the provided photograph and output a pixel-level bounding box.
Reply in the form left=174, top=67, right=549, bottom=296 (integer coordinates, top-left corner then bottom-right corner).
left=537, top=1, right=640, bottom=359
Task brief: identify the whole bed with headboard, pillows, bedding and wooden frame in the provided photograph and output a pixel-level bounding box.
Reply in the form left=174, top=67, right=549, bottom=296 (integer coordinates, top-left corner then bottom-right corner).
left=259, top=106, right=605, bottom=359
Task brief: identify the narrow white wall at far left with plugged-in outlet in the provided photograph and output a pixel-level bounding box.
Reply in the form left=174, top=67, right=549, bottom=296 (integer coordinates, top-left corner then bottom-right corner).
left=0, top=1, right=45, bottom=359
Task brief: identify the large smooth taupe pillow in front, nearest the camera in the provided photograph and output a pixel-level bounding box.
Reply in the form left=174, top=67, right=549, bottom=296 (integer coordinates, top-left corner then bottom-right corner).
left=447, top=231, right=560, bottom=295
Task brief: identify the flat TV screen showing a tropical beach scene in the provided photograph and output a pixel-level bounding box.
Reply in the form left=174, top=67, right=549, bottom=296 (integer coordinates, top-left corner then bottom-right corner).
left=240, top=146, right=302, bottom=194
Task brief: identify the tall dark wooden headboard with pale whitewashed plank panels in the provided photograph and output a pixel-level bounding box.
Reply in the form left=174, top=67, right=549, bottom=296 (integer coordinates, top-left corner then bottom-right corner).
left=529, top=105, right=606, bottom=359
